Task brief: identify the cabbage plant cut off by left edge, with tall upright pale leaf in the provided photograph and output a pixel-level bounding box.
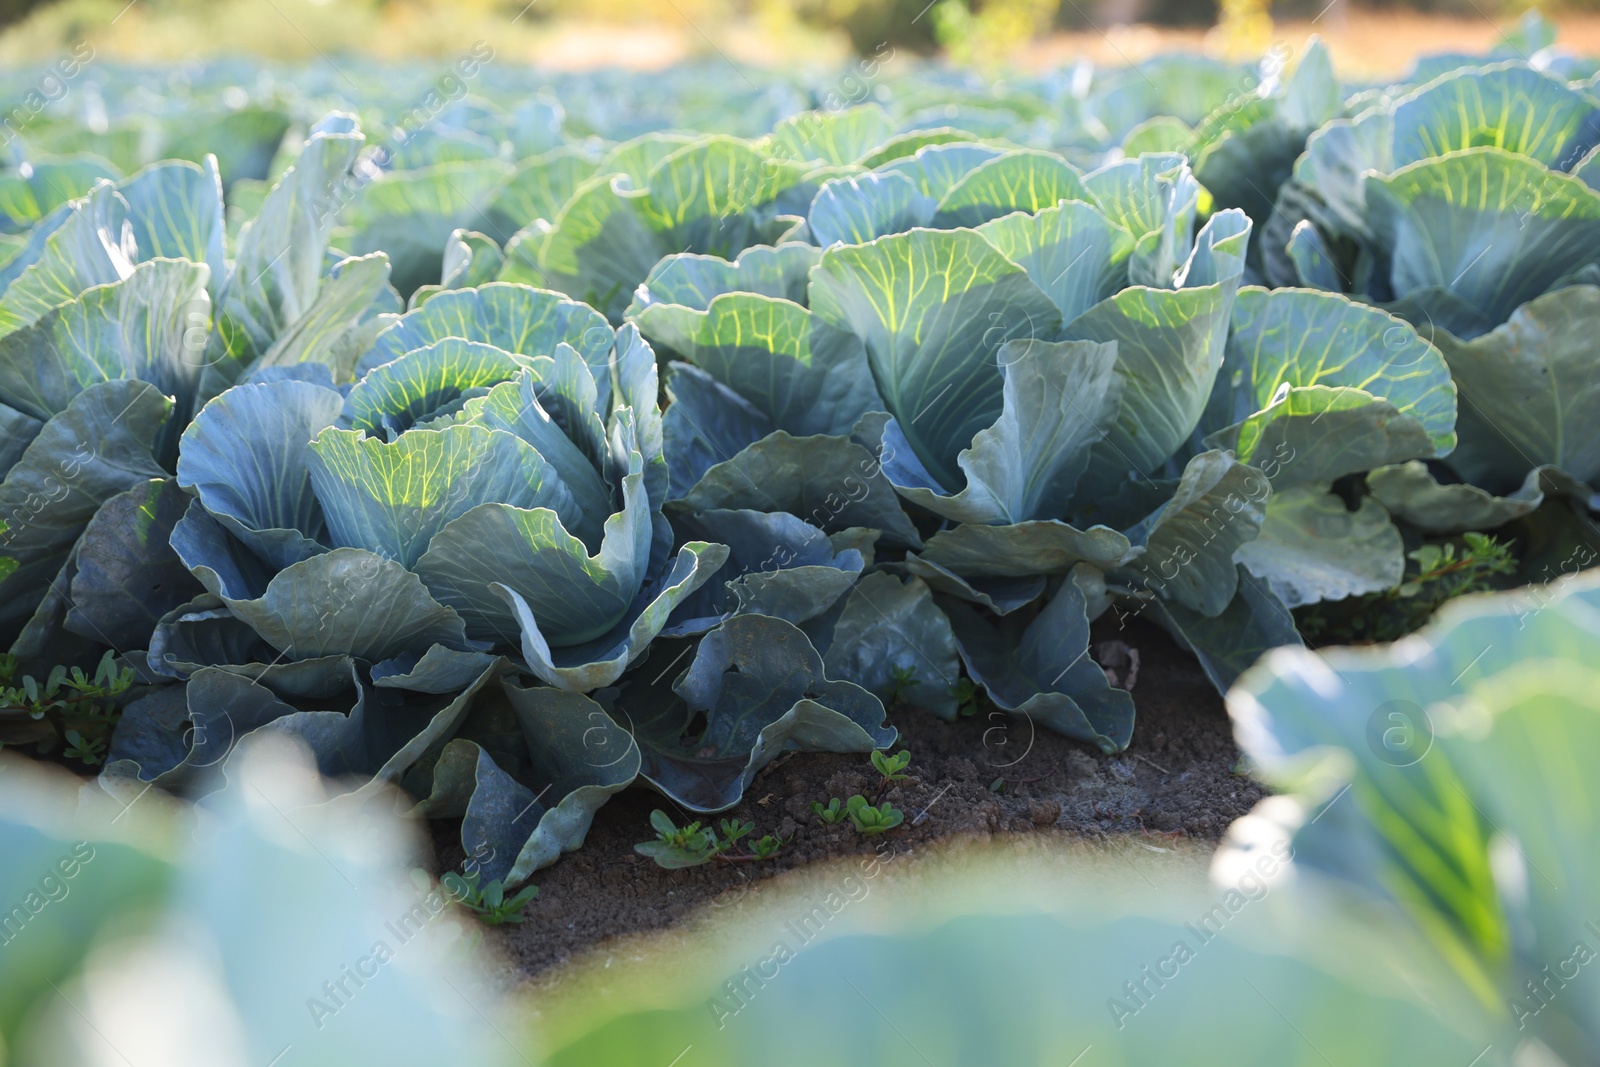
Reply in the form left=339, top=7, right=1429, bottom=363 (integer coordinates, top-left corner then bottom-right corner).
left=0, top=115, right=394, bottom=684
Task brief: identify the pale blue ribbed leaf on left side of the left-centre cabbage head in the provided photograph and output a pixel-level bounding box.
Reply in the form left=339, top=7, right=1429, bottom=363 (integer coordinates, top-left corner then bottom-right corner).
left=178, top=381, right=344, bottom=568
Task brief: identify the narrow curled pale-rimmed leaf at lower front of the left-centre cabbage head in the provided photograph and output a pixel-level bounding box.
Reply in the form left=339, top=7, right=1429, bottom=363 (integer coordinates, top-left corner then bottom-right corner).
left=491, top=541, right=728, bottom=693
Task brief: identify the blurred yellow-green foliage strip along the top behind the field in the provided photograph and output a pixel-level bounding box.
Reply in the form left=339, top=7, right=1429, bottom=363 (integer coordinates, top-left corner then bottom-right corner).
left=0, top=0, right=1580, bottom=75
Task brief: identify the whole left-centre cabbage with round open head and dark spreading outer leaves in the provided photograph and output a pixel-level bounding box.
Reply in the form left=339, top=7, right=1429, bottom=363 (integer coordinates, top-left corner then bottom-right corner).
left=110, top=283, right=894, bottom=880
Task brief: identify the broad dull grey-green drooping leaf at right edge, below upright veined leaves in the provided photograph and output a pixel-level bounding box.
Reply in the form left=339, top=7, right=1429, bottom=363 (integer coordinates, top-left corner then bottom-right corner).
left=1434, top=285, right=1600, bottom=493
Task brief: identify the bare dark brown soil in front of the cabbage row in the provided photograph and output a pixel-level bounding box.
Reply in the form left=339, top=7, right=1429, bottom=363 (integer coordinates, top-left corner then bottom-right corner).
left=432, top=617, right=1264, bottom=981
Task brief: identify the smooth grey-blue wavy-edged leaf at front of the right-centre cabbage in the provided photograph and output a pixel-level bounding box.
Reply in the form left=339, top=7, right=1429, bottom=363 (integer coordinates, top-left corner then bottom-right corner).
left=883, top=341, right=1122, bottom=525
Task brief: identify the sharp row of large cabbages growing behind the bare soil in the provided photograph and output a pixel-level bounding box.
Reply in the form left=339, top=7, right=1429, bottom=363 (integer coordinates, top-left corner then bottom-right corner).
left=0, top=35, right=1600, bottom=880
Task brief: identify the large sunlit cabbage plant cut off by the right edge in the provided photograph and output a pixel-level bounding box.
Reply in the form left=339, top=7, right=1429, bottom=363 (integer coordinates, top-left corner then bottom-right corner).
left=1264, top=61, right=1600, bottom=533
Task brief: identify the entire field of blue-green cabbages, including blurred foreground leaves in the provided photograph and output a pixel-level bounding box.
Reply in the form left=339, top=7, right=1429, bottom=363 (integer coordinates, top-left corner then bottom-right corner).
left=0, top=10, right=1600, bottom=1067
